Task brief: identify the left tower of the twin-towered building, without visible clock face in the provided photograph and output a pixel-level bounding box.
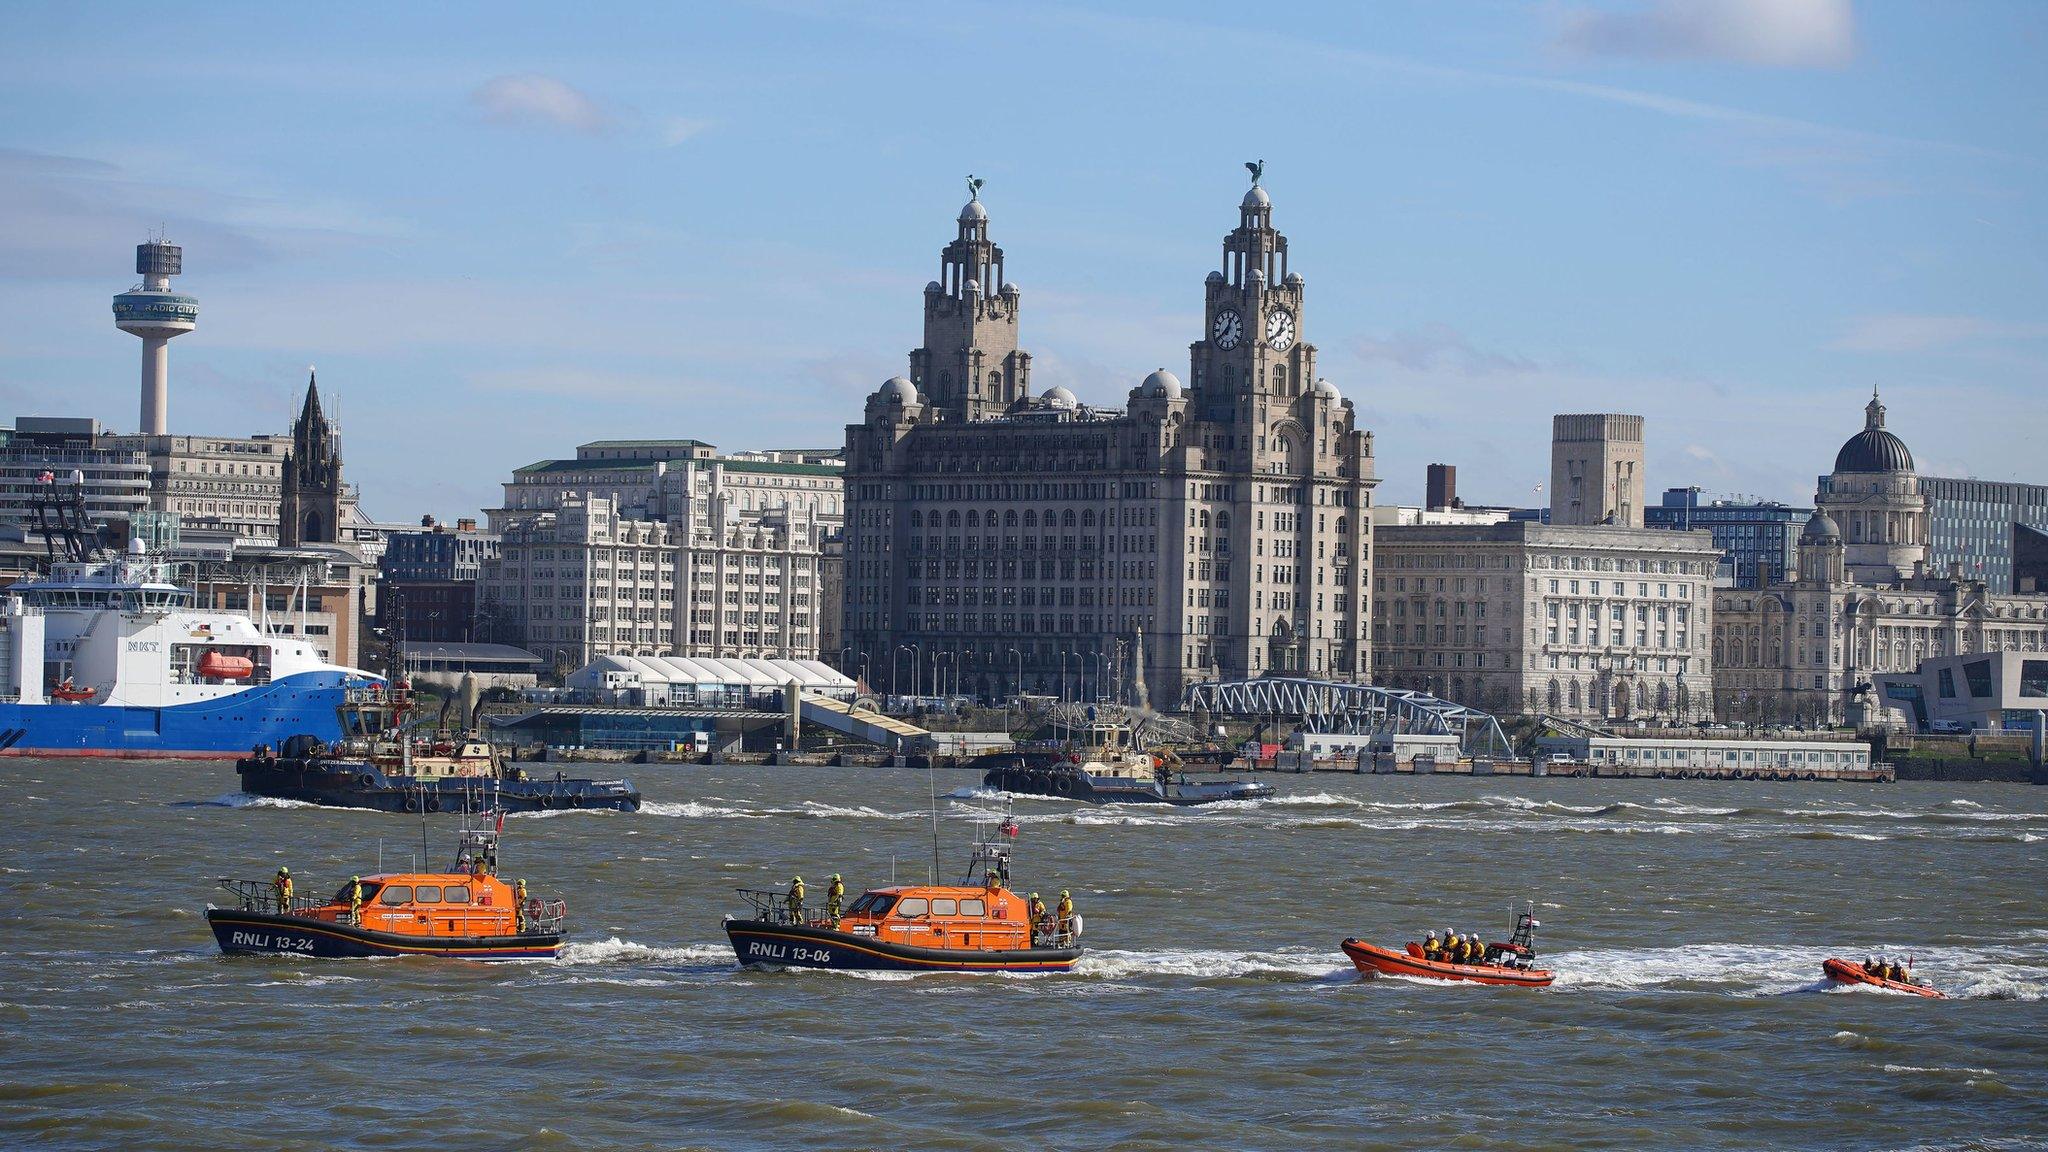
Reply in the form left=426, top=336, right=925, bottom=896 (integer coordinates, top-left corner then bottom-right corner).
left=909, top=176, right=1030, bottom=422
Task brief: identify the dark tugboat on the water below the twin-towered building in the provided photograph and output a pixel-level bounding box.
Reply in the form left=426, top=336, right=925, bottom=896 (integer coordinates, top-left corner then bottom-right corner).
left=981, top=719, right=1274, bottom=806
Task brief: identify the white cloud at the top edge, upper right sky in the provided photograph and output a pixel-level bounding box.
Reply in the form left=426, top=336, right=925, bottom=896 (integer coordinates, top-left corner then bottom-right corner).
left=1556, top=0, right=1855, bottom=68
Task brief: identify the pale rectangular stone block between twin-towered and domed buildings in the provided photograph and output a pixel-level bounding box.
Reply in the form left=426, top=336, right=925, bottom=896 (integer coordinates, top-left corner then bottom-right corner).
left=1372, top=521, right=1720, bottom=719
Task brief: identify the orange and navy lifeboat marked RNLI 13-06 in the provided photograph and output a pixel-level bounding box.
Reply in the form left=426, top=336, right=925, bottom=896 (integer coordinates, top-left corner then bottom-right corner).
left=725, top=810, right=1081, bottom=972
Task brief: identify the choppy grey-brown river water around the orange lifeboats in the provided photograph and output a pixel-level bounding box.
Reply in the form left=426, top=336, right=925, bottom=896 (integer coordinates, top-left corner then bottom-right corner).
left=0, top=760, right=2048, bottom=1152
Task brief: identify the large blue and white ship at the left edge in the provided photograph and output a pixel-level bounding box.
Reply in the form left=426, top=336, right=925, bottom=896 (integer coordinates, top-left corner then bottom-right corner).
left=0, top=541, right=379, bottom=758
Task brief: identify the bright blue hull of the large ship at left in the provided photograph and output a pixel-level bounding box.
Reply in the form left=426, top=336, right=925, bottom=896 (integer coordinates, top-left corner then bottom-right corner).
left=0, top=672, right=360, bottom=760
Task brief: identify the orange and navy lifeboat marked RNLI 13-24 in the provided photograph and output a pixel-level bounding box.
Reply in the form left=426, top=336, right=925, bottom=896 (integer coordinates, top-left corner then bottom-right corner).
left=207, top=812, right=567, bottom=959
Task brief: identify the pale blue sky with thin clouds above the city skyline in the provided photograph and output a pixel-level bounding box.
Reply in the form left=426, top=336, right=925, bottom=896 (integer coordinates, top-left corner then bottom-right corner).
left=0, top=0, right=2048, bottom=521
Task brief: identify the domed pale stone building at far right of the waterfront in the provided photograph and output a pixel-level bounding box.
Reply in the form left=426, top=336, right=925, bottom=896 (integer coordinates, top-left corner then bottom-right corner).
left=1714, top=396, right=2048, bottom=724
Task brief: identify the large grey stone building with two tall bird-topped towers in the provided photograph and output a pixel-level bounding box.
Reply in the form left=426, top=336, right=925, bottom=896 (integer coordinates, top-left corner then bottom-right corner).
left=842, top=178, right=1376, bottom=705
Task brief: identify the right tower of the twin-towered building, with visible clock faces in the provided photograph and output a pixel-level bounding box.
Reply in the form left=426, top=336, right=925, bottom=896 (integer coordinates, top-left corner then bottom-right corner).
left=1190, top=166, right=1315, bottom=424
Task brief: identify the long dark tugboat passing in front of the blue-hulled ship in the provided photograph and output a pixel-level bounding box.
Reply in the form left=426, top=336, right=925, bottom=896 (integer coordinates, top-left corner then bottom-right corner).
left=236, top=681, right=641, bottom=812
